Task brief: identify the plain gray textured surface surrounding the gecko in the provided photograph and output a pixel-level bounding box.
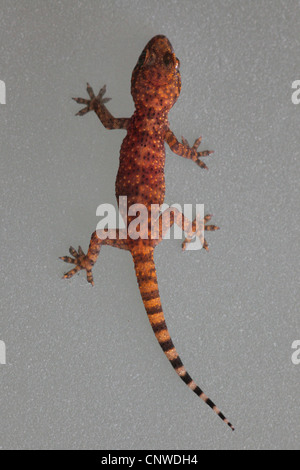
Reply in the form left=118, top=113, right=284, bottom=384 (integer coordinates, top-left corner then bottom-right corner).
left=0, top=0, right=300, bottom=449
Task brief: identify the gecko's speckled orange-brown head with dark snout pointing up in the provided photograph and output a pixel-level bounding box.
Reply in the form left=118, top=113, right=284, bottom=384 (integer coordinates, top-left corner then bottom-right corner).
left=131, top=35, right=181, bottom=110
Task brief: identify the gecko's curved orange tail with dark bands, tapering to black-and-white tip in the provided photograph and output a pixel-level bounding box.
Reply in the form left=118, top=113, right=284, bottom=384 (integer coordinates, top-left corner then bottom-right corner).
left=132, top=245, right=234, bottom=431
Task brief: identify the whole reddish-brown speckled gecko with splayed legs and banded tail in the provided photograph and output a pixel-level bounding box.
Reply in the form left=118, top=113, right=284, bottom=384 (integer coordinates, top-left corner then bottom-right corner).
left=60, top=35, right=234, bottom=430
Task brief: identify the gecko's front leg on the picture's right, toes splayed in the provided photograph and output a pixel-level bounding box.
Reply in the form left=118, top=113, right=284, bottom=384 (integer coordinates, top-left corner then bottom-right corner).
left=165, top=128, right=214, bottom=170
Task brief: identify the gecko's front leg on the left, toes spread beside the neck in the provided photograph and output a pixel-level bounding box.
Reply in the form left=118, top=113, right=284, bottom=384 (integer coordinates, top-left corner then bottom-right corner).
left=73, top=83, right=129, bottom=129
